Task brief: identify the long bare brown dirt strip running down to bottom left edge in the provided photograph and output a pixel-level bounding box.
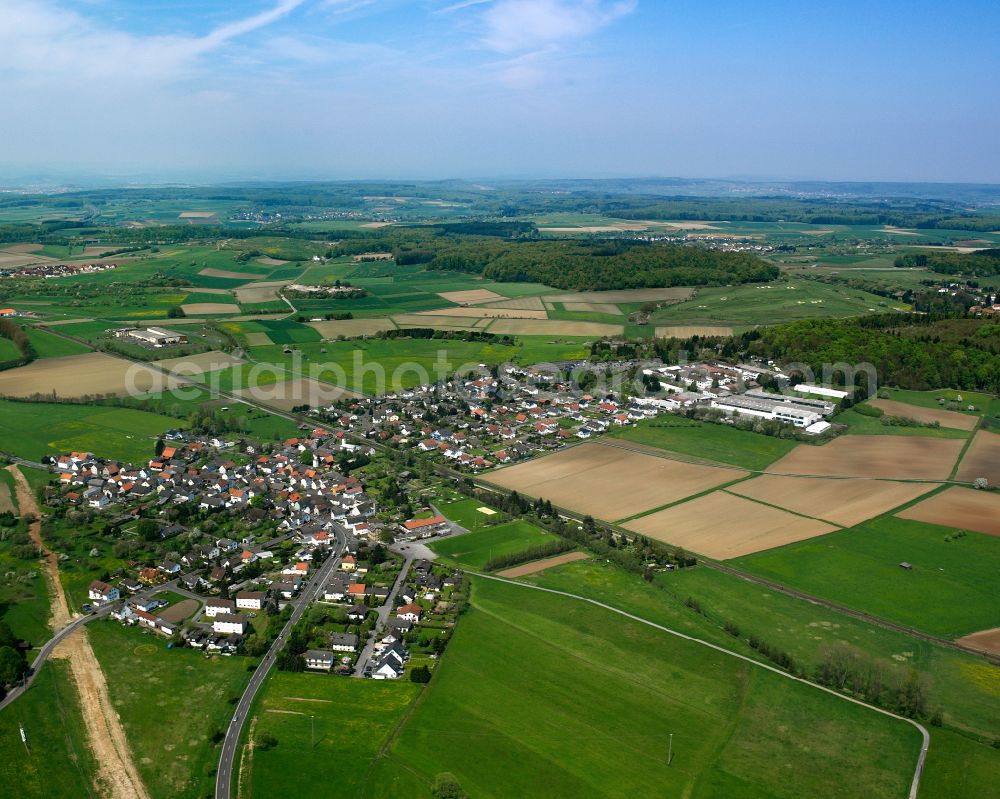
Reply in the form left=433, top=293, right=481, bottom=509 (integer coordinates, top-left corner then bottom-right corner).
left=8, top=466, right=149, bottom=799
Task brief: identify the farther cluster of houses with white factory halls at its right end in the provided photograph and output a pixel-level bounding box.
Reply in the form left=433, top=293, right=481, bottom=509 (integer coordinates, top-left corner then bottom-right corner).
left=316, top=363, right=847, bottom=472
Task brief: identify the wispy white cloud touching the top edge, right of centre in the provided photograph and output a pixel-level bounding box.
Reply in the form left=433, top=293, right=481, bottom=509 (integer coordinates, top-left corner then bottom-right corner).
left=483, top=0, right=637, bottom=53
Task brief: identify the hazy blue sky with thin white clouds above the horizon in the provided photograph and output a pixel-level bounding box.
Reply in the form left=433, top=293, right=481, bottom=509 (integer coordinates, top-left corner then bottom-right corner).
left=0, top=0, right=1000, bottom=182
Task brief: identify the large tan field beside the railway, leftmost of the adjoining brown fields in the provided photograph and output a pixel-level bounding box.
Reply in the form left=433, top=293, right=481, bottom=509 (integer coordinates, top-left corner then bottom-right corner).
left=489, top=444, right=747, bottom=521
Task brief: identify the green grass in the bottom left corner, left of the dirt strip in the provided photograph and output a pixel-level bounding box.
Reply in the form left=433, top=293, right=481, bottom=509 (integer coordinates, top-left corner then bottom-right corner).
left=0, top=661, right=99, bottom=799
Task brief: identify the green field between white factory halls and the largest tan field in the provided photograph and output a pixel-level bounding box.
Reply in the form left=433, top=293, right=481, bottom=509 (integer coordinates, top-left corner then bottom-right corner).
left=611, top=416, right=797, bottom=469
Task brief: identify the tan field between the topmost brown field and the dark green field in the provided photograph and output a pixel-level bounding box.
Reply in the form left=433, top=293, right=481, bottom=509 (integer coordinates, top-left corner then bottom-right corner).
left=727, top=474, right=934, bottom=527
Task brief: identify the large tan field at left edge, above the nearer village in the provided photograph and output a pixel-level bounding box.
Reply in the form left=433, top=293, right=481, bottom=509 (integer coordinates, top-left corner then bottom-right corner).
left=0, top=352, right=180, bottom=398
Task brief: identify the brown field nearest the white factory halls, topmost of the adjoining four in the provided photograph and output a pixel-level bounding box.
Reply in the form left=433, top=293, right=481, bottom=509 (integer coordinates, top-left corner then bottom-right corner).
left=767, top=435, right=965, bottom=480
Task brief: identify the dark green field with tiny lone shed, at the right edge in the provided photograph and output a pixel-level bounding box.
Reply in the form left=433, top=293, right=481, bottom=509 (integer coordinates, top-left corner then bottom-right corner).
left=733, top=517, right=1000, bottom=638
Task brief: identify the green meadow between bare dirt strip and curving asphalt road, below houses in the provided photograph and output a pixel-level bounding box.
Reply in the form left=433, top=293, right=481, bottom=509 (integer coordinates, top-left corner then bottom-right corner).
left=87, top=621, right=250, bottom=799
